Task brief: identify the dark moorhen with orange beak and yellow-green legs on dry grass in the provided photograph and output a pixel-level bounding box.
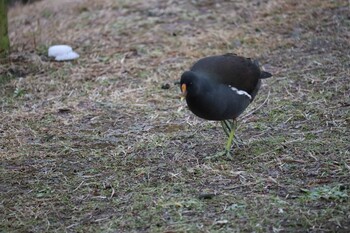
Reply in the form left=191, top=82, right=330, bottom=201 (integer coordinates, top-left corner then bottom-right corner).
left=180, top=53, right=272, bottom=158
